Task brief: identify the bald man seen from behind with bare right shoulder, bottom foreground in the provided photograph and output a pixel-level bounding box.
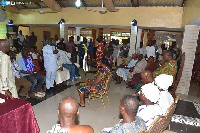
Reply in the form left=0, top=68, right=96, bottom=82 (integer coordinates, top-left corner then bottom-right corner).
left=47, top=97, right=94, bottom=133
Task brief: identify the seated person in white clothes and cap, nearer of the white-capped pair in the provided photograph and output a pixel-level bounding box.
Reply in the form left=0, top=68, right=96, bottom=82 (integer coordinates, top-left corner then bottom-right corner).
left=137, top=83, right=163, bottom=127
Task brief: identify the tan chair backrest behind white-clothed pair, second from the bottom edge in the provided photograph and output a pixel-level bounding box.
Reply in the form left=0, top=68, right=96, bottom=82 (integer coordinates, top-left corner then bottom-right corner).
left=164, top=103, right=177, bottom=129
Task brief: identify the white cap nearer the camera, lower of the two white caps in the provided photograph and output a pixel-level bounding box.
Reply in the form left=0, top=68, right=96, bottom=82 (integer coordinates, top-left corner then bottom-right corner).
left=141, top=83, right=160, bottom=103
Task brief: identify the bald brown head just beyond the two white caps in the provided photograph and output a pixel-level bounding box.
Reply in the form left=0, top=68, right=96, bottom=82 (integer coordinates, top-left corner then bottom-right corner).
left=141, top=70, right=153, bottom=84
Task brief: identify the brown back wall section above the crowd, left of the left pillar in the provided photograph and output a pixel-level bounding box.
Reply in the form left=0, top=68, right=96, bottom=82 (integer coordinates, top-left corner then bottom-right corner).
left=30, top=26, right=60, bottom=50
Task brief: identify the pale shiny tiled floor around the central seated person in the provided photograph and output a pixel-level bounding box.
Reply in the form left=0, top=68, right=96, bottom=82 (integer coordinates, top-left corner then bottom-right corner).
left=33, top=68, right=200, bottom=133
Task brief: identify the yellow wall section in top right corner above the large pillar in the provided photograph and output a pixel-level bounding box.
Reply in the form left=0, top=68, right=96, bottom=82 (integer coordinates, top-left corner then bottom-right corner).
left=181, top=0, right=200, bottom=27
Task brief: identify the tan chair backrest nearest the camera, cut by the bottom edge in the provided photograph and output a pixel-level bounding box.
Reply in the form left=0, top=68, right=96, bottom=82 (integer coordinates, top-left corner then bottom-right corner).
left=140, top=116, right=166, bottom=133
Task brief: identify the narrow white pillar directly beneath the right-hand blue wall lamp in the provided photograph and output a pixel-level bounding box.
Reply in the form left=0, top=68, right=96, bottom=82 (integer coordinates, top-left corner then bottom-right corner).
left=129, top=25, right=137, bottom=56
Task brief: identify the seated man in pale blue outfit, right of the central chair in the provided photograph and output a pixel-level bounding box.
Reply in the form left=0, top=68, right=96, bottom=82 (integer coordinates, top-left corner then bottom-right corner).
left=116, top=54, right=138, bottom=84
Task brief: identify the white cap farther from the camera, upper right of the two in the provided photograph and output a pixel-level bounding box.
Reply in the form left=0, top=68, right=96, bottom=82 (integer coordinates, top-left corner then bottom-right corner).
left=154, top=74, right=173, bottom=91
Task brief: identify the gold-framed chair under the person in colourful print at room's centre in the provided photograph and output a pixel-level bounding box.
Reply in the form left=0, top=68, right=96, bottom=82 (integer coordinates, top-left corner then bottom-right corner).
left=88, top=74, right=112, bottom=108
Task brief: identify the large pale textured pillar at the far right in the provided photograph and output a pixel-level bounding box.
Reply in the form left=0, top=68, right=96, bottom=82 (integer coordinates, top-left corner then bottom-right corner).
left=176, top=25, right=199, bottom=94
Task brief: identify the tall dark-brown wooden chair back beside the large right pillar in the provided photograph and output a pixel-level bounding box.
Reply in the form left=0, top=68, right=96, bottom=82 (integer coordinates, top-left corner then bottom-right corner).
left=169, top=52, right=185, bottom=99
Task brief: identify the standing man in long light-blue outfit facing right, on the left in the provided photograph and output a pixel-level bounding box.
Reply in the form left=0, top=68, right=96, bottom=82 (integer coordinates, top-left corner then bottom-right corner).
left=43, top=39, right=58, bottom=92
